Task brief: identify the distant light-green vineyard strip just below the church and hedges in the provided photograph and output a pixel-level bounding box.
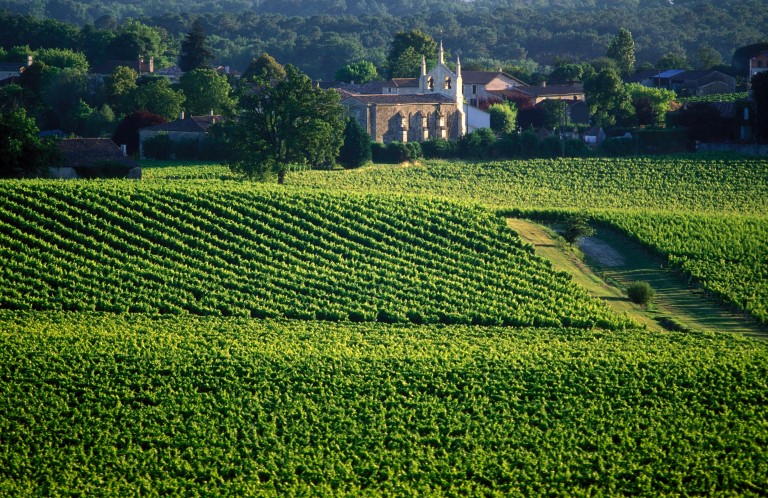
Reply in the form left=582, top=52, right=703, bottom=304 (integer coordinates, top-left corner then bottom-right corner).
left=287, top=155, right=768, bottom=214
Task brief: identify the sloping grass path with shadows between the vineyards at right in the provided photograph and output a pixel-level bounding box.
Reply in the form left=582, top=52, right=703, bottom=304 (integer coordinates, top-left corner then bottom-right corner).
left=507, top=218, right=768, bottom=338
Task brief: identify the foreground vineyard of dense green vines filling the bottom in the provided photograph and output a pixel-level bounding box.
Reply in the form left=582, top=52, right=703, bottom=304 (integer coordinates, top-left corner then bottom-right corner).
left=0, top=312, right=768, bottom=496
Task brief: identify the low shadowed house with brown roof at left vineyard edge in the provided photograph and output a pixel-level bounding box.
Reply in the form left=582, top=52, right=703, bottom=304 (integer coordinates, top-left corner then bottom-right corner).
left=50, top=138, right=141, bottom=179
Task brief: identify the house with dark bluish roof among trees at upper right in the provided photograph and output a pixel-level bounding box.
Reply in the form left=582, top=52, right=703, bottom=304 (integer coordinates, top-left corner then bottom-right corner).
left=629, top=69, right=736, bottom=97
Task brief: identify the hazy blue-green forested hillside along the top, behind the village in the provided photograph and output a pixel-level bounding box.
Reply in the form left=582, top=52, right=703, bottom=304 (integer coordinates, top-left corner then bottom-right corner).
left=0, top=0, right=768, bottom=79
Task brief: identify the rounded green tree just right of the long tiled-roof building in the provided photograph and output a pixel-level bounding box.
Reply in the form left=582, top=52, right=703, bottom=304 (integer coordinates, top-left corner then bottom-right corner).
left=584, top=69, right=634, bottom=126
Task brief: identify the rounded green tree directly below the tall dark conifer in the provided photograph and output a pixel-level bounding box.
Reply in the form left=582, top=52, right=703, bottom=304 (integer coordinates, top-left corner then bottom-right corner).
left=179, top=68, right=235, bottom=116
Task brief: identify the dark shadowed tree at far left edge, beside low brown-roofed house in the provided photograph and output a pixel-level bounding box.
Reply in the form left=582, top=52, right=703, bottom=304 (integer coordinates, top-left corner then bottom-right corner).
left=0, top=109, right=58, bottom=178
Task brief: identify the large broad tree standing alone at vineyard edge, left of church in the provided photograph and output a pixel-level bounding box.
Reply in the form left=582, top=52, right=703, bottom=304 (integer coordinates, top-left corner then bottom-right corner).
left=225, top=64, right=344, bottom=184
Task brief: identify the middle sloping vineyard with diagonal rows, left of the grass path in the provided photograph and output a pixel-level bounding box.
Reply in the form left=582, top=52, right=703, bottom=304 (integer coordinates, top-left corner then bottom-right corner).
left=0, top=181, right=629, bottom=329
